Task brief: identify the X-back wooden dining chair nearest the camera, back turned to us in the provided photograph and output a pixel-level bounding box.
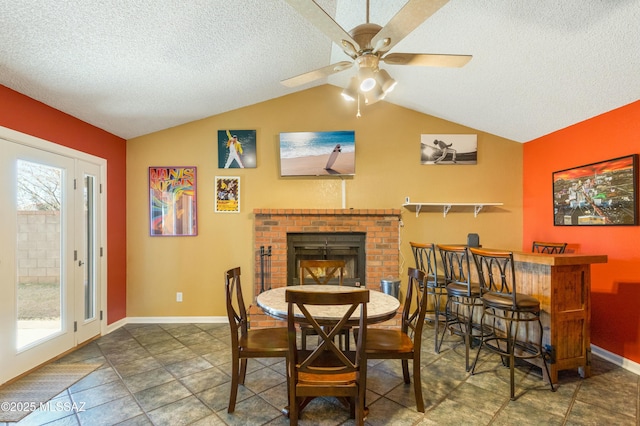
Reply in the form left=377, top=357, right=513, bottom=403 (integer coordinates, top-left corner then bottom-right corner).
left=285, top=287, right=369, bottom=425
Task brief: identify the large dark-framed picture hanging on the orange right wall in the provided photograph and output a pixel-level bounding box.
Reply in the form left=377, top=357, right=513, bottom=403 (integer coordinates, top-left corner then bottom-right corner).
left=552, top=154, right=638, bottom=226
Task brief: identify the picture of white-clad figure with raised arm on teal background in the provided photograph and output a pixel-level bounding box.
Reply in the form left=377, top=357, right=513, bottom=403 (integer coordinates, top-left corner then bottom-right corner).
left=218, top=129, right=257, bottom=169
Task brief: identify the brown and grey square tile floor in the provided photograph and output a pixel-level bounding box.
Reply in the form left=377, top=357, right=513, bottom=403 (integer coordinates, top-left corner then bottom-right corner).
left=0, top=324, right=640, bottom=426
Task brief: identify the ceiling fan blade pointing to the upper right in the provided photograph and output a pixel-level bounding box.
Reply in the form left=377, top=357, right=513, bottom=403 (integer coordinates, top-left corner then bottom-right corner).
left=370, top=0, right=449, bottom=52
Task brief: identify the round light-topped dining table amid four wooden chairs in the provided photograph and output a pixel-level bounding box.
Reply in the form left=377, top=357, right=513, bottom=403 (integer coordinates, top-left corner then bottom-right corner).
left=256, top=284, right=400, bottom=325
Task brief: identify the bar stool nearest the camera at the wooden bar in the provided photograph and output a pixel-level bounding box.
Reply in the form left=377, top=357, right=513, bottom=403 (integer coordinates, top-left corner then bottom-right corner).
left=469, top=248, right=555, bottom=400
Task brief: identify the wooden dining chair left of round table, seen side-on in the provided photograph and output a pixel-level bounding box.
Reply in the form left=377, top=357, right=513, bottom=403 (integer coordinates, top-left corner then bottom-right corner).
left=224, top=267, right=288, bottom=413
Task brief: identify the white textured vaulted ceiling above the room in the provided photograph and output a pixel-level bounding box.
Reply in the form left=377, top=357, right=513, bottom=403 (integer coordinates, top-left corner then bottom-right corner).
left=0, top=0, right=640, bottom=142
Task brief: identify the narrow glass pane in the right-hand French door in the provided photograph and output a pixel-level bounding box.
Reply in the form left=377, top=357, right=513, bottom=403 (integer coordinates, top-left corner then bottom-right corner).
left=83, top=175, right=96, bottom=320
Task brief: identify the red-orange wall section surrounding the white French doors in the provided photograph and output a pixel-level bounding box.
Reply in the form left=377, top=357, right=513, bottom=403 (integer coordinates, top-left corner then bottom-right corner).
left=0, top=85, right=127, bottom=324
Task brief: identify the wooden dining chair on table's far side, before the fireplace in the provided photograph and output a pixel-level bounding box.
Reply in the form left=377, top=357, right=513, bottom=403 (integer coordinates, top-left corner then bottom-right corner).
left=298, top=260, right=350, bottom=349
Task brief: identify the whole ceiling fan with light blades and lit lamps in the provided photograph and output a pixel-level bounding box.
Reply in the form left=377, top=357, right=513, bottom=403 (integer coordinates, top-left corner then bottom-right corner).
left=281, top=0, right=471, bottom=104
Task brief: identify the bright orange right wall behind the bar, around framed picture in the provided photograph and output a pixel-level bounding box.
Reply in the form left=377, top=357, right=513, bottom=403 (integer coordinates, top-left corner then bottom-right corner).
left=522, top=101, right=640, bottom=362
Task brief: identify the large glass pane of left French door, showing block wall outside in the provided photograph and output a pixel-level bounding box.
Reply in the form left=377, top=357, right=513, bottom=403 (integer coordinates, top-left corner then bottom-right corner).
left=16, top=160, right=63, bottom=349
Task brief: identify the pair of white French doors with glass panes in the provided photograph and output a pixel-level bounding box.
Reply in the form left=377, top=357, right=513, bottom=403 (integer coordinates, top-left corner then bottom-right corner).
left=0, top=138, right=103, bottom=384
